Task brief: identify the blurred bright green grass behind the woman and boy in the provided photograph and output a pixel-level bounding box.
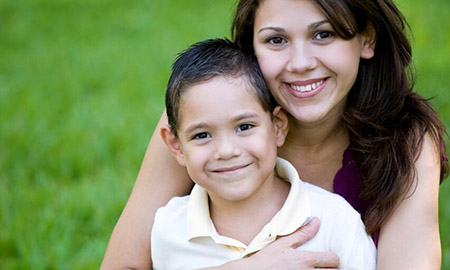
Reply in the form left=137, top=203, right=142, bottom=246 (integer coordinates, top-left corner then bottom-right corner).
left=0, top=0, right=450, bottom=269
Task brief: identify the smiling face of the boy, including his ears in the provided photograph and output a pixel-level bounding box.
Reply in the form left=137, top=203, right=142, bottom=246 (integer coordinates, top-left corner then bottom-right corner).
left=167, top=76, right=287, bottom=201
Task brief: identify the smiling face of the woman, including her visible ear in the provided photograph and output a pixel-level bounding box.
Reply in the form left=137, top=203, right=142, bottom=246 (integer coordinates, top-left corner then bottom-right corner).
left=253, top=0, right=373, bottom=124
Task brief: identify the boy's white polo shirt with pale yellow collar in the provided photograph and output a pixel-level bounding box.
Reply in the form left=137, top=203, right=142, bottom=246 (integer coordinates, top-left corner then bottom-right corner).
left=151, top=158, right=376, bottom=270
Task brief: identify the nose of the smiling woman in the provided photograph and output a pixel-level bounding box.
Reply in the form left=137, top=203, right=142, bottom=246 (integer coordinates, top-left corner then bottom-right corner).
left=287, top=43, right=318, bottom=73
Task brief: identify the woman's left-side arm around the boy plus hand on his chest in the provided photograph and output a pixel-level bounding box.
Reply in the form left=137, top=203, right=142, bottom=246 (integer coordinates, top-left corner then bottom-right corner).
left=101, top=110, right=339, bottom=270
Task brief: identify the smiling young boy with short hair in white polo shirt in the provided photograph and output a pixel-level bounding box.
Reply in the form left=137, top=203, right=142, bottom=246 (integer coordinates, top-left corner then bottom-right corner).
left=151, top=39, right=376, bottom=269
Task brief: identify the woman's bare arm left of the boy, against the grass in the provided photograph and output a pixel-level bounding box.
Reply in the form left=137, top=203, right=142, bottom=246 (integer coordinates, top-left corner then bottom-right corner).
left=101, top=112, right=193, bottom=269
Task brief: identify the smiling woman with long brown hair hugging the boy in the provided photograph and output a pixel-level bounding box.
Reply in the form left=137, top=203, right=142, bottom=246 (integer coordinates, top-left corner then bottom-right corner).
left=103, top=0, right=448, bottom=269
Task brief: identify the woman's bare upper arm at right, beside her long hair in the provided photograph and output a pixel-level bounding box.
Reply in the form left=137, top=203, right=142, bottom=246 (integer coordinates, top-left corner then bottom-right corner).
left=377, top=135, right=441, bottom=270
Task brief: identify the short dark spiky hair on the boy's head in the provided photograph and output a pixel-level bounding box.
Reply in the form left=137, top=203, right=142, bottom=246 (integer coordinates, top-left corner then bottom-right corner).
left=166, top=39, right=276, bottom=136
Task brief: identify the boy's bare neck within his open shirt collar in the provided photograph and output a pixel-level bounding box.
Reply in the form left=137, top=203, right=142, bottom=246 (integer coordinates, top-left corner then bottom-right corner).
left=209, top=174, right=290, bottom=245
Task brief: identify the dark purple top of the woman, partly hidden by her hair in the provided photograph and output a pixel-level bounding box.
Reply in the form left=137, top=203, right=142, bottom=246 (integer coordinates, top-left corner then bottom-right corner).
left=333, top=147, right=379, bottom=246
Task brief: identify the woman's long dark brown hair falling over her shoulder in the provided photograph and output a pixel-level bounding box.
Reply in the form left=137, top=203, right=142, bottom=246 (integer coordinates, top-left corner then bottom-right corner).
left=231, top=0, right=448, bottom=234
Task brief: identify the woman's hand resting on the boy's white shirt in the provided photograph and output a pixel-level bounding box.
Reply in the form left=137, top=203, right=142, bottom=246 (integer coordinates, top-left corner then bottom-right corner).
left=206, top=217, right=339, bottom=270
